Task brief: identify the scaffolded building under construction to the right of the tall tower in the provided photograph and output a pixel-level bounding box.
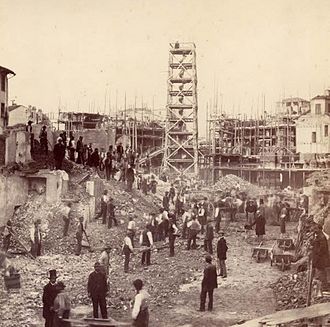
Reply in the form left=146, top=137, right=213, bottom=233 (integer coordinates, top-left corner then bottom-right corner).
left=201, top=99, right=328, bottom=188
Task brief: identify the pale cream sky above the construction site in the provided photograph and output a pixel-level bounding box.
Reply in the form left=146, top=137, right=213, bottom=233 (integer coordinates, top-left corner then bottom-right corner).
left=0, top=0, right=330, bottom=134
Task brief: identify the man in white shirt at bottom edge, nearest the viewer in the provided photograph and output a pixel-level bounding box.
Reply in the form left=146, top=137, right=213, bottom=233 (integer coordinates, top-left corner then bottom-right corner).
left=132, top=279, right=150, bottom=327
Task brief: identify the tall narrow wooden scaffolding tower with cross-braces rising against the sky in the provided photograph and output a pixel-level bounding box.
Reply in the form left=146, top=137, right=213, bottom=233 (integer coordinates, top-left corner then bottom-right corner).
left=164, top=42, right=198, bottom=175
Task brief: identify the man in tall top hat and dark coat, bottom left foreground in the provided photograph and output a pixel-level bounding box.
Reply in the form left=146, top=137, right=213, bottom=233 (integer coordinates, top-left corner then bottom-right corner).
left=42, top=269, right=58, bottom=327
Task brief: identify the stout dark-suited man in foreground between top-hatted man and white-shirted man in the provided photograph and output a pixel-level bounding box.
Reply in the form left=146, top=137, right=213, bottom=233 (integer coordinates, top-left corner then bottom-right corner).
left=87, top=262, right=108, bottom=319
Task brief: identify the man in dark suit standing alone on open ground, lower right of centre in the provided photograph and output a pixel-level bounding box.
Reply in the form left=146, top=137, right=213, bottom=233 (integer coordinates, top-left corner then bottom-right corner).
left=199, top=255, right=218, bottom=311
